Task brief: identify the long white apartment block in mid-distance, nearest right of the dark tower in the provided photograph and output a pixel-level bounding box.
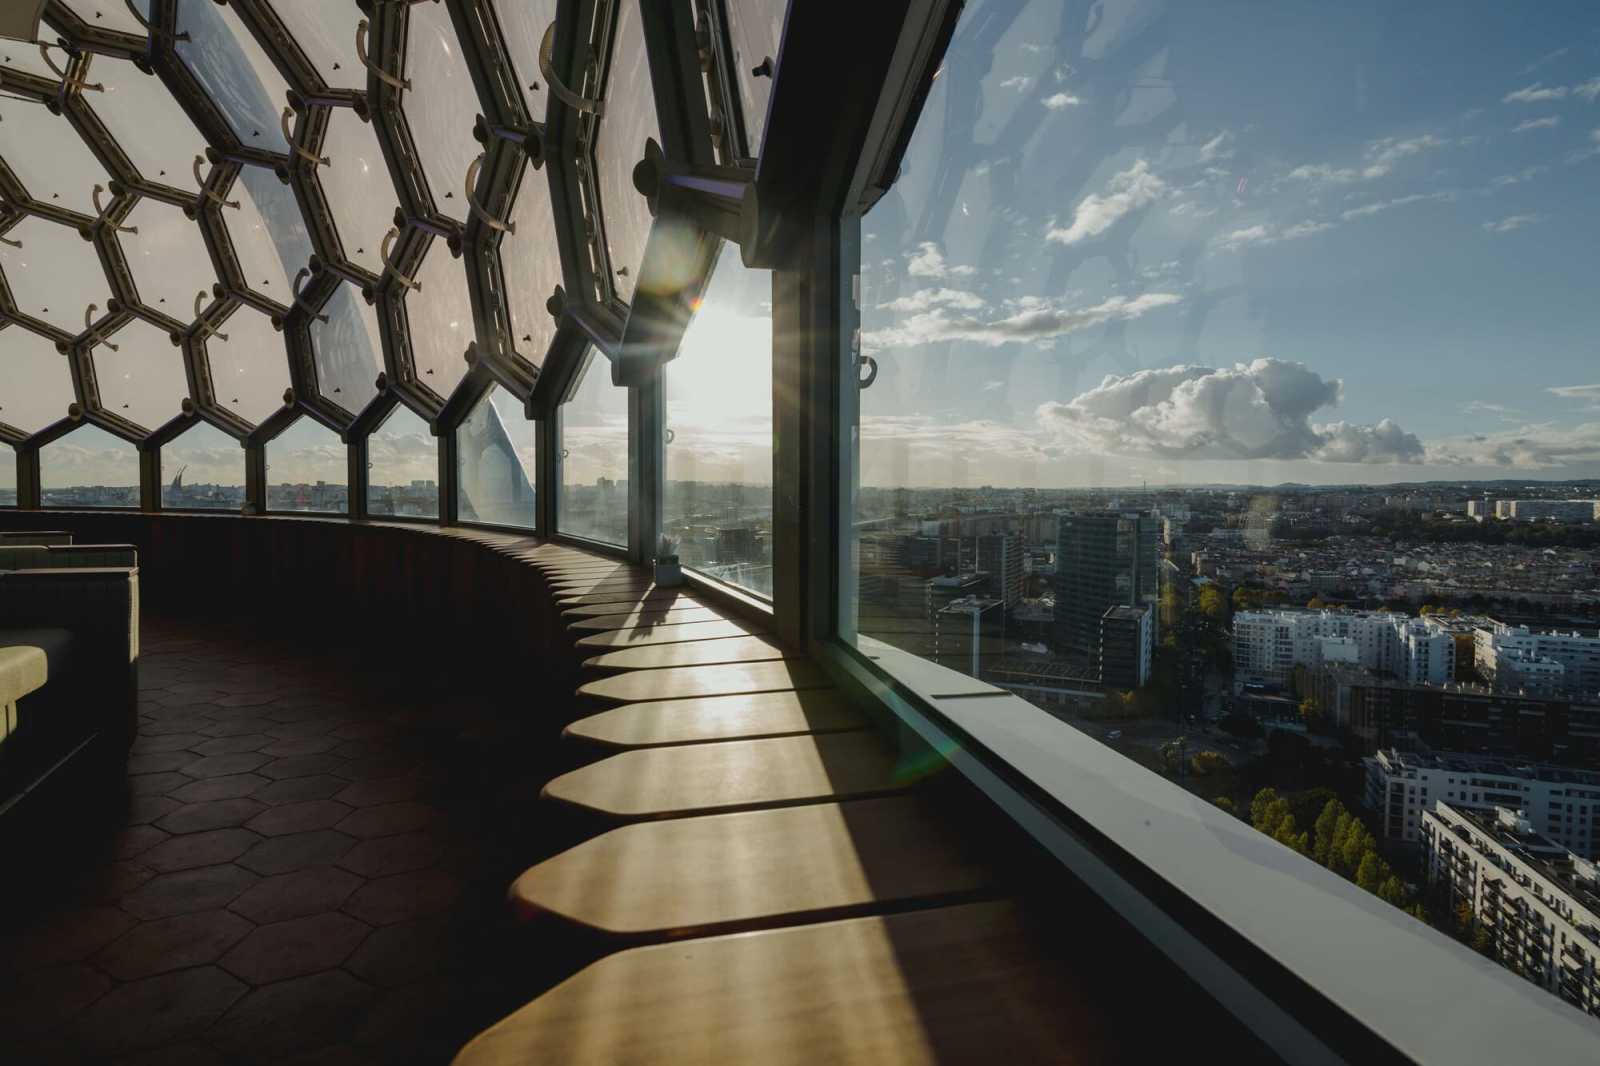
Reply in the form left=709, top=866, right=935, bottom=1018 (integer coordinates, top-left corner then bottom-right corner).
left=1234, top=610, right=1456, bottom=685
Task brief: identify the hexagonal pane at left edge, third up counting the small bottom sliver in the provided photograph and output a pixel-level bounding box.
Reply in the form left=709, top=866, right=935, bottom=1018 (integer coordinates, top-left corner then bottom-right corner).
left=0, top=214, right=110, bottom=333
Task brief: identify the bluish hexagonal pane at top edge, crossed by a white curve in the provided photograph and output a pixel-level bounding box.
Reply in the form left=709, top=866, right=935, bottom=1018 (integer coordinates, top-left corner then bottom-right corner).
left=178, top=2, right=290, bottom=152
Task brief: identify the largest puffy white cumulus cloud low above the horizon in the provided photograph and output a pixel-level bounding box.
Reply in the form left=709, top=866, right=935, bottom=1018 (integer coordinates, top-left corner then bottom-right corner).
left=1038, top=359, right=1424, bottom=463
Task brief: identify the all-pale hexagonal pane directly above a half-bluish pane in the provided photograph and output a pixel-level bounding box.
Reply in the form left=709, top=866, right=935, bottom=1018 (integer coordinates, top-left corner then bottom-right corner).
left=317, top=107, right=398, bottom=274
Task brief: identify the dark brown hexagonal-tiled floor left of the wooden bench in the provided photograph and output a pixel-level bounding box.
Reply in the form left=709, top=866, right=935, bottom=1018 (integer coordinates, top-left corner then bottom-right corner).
left=0, top=618, right=542, bottom=1064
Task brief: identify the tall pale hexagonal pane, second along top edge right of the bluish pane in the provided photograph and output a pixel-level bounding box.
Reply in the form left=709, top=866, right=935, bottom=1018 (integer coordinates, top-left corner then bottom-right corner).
left=400, top=3, right=483, bottom=222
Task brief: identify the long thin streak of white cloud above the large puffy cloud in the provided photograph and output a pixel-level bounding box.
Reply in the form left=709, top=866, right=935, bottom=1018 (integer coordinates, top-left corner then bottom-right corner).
left=861, top=293, right=1181, bottom=352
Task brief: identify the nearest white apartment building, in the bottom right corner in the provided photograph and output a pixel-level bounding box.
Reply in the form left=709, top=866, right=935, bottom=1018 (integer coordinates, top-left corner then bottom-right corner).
left=1422, top=800, right=1600, bottom=1016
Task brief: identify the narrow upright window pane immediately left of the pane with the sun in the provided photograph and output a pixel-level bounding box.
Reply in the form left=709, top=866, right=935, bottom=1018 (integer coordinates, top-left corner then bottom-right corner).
left=557, top=352, right=627, bottom=544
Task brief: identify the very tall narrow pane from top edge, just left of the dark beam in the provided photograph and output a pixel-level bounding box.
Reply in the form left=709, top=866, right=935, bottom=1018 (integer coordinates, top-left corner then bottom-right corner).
left=595, top=3, right=661, bottom=301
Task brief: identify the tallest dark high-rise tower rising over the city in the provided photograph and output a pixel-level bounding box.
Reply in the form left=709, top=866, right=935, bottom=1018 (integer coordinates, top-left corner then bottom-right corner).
left=1056, top=512, right=1162, bottom=663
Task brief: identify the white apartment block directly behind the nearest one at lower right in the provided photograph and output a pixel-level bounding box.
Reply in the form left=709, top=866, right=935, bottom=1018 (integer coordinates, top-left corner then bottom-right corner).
left=1362, top=749, right=1600, bottom=858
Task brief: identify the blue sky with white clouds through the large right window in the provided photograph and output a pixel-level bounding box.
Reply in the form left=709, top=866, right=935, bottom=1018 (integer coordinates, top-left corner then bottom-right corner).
left=862, top=0, right=1600, bottom=485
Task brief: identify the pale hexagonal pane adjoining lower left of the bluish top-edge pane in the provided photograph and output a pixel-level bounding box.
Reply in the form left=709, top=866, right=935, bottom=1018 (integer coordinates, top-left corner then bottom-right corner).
left=85, top=56, right=205, bottom=185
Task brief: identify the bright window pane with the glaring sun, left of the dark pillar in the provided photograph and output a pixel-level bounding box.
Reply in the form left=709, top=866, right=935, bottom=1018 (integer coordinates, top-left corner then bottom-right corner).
left=661, top=246, right=773, bottom=595
